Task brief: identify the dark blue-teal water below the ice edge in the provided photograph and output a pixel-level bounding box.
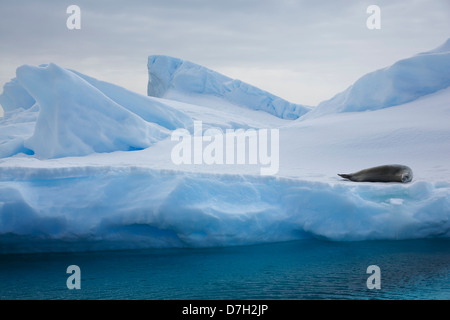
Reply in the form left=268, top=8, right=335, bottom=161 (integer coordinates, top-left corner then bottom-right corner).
left=0, top=240, right=450, bottom=300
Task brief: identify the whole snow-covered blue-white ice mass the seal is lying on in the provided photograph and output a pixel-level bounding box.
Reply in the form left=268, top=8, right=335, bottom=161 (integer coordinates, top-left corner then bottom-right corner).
left=0, top=39, right=450, bottom=253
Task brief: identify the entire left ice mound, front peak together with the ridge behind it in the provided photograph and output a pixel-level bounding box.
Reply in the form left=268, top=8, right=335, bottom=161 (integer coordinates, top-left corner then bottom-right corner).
left=0, top=64, right=192, bottom=158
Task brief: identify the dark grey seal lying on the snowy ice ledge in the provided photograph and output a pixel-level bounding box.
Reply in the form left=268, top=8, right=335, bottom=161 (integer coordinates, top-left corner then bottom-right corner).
left=338, top=164, right=413, bottom=183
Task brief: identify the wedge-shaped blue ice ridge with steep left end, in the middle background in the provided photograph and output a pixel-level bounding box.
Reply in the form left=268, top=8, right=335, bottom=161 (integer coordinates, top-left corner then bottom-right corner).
left=148, top=55, right=311, bottom=119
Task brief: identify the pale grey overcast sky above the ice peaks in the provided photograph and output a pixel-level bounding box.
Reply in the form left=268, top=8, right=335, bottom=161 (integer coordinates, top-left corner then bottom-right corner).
left=0, top=0, right=450, bottom=106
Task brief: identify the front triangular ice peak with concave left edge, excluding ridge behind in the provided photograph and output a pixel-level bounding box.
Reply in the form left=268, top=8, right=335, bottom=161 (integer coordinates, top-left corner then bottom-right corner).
left=17, top=64, right=167, bottom=158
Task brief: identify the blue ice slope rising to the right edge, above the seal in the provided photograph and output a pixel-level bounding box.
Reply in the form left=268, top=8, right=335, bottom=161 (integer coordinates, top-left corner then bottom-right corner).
left=302, top=39, right=450, bottom=119
